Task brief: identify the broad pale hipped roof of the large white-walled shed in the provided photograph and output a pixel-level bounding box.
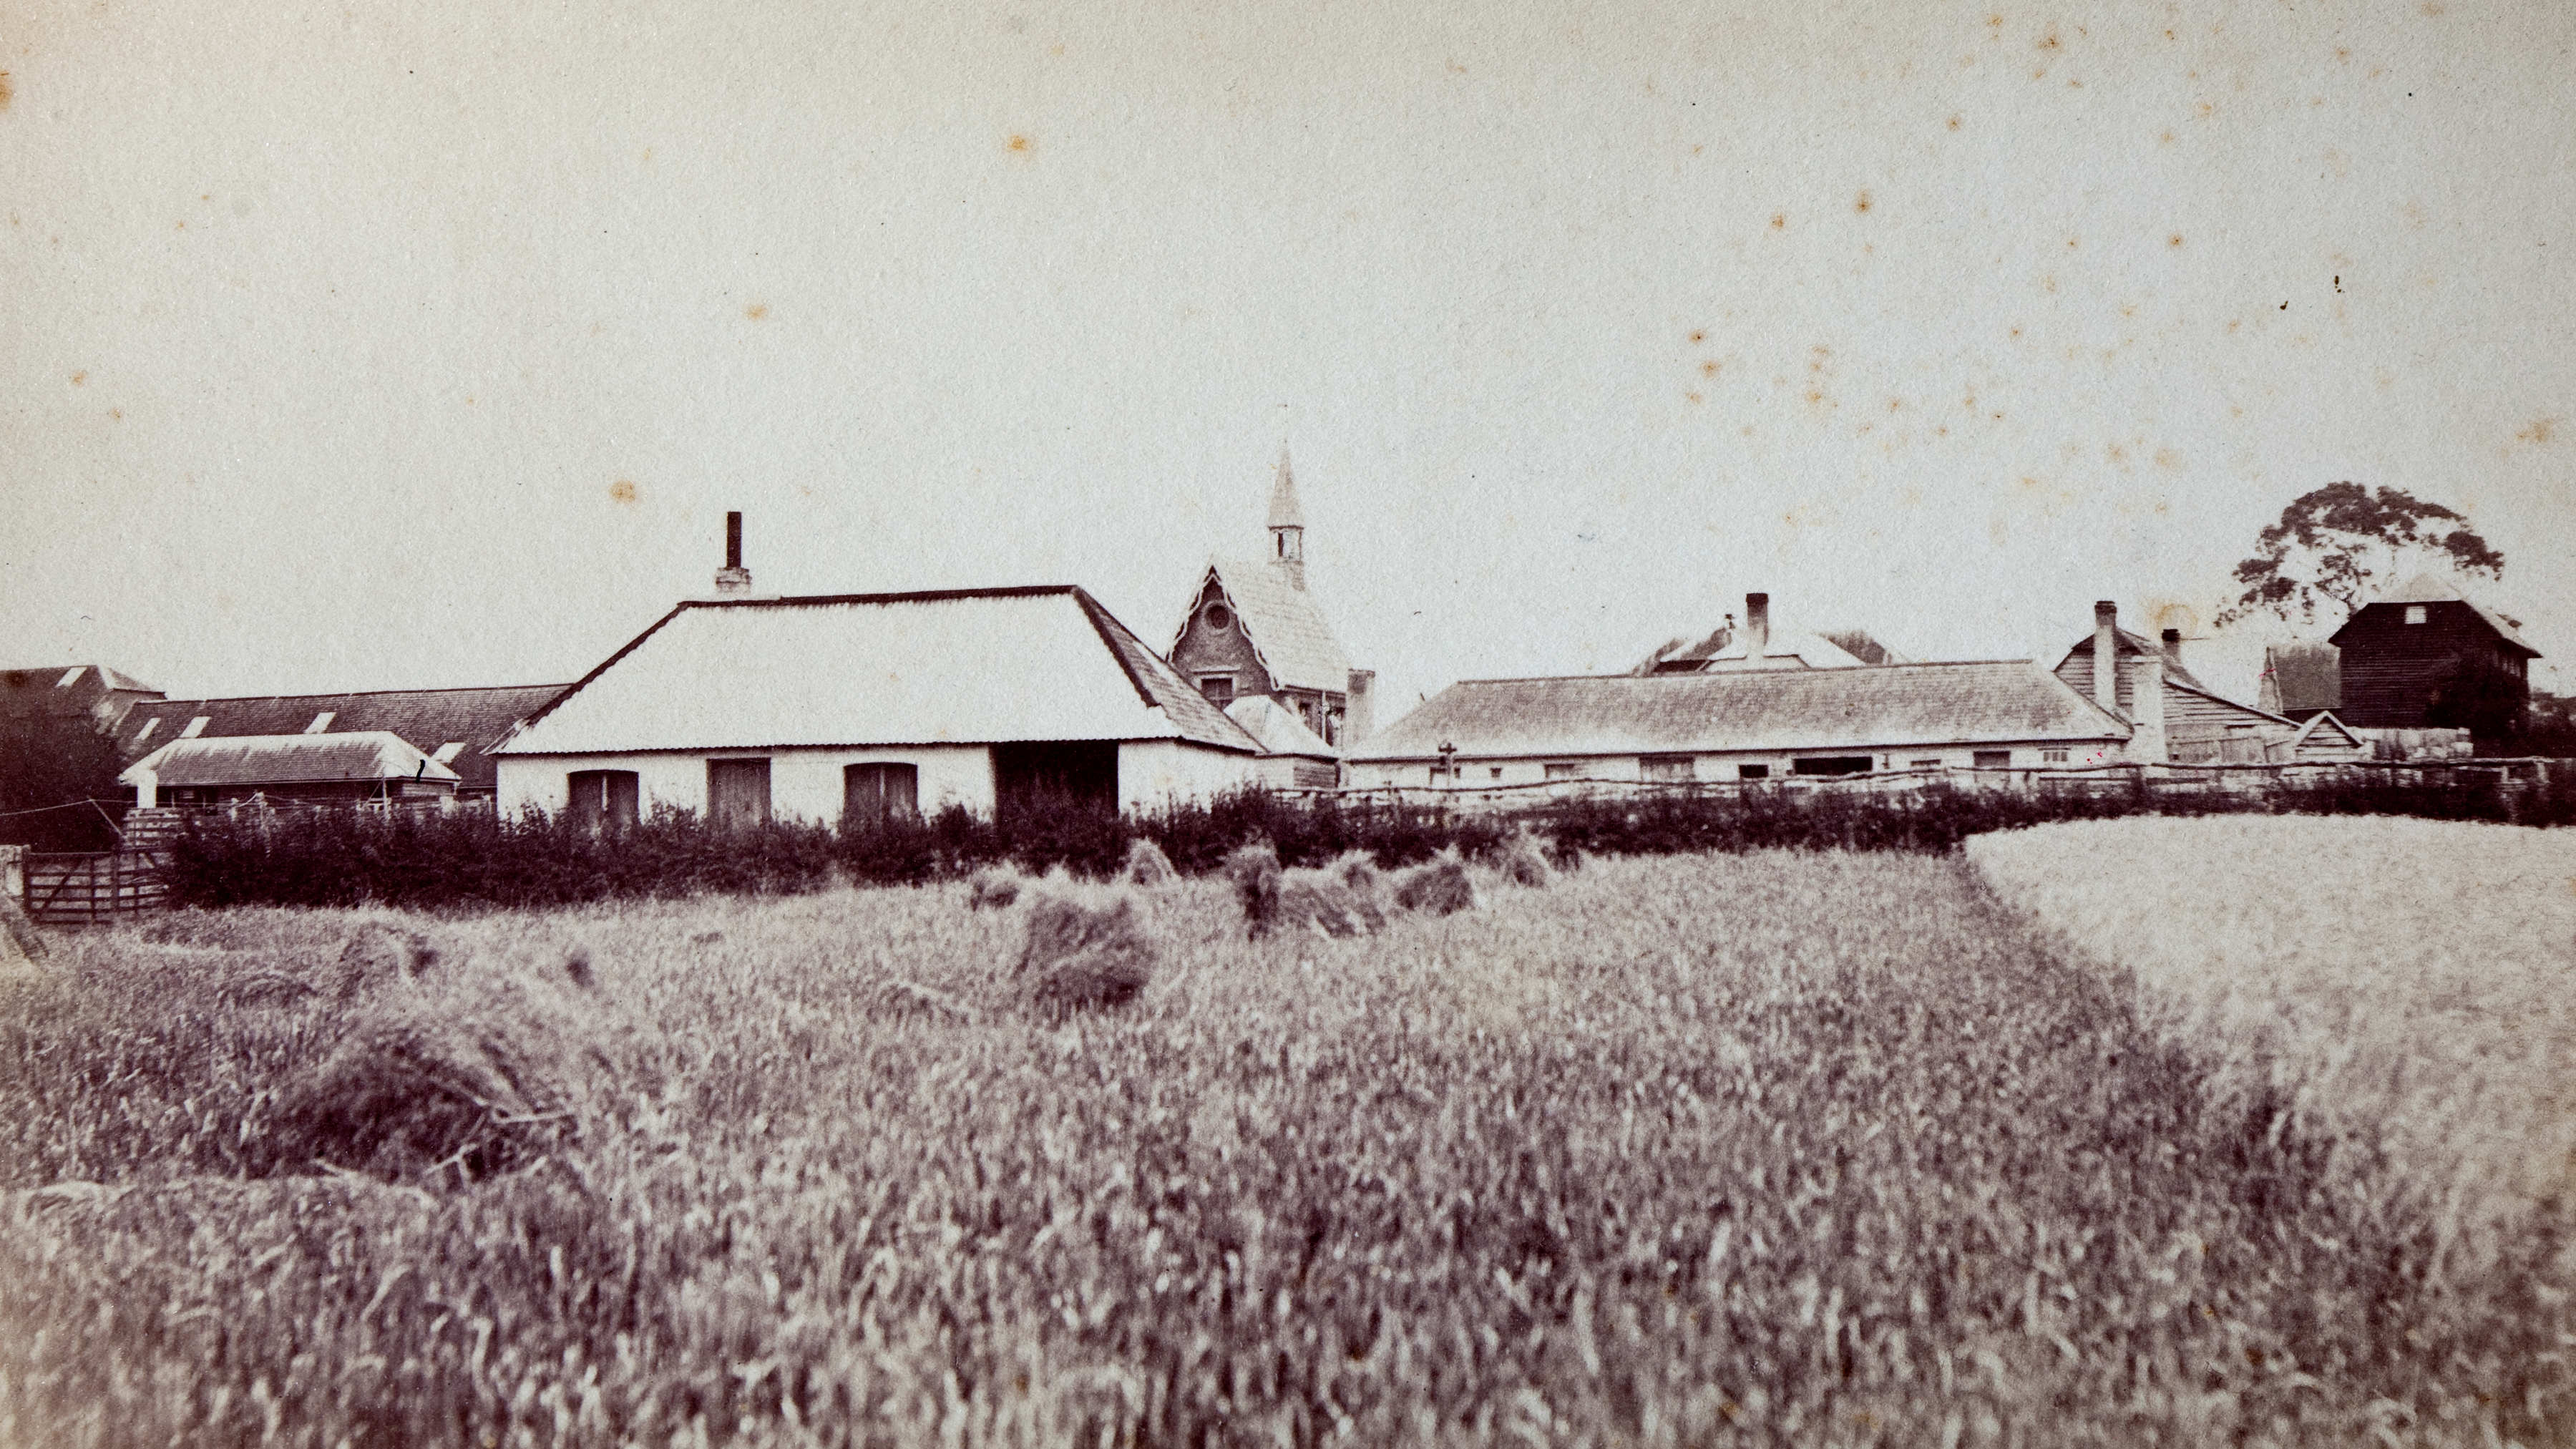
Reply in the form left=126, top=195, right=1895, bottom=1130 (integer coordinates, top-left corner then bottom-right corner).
left=494, top=585, right=1257, bottom=756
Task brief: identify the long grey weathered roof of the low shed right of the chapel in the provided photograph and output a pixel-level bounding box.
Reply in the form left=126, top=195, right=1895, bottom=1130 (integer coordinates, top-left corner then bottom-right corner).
left=1350, top=660, right=2130, bottom=761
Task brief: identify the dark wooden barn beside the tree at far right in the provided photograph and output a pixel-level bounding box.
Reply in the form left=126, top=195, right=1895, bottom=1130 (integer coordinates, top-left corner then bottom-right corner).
left=2334, top=575, right=2540, bottom=732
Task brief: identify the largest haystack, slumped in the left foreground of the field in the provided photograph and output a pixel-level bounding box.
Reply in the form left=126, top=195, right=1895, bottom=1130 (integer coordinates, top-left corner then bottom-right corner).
left=265, top=949, right=649, bottom=1181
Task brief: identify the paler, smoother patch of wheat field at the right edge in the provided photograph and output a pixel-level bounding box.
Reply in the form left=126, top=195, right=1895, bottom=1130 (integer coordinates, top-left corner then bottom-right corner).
left=1966, top=815, right=2576, bottom=1271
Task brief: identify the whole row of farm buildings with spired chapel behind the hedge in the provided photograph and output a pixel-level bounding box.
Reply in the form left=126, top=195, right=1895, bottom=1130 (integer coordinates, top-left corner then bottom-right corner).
left=0, top=454, right=2540, bottom=822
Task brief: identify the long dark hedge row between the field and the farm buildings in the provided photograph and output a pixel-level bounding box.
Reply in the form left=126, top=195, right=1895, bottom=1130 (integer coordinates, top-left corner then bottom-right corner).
left=170, top=763, right=2576, bottom=910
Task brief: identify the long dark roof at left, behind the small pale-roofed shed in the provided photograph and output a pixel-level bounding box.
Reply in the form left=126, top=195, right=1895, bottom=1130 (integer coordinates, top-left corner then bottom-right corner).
left=116, top=683, right=564, bottom=789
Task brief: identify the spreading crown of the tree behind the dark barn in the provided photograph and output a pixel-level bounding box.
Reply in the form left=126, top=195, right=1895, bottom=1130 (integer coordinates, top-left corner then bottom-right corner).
left=2218, top=482, right=2504, bottom=624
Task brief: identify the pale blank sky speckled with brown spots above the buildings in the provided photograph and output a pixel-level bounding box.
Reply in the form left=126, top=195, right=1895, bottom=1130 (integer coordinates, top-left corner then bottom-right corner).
left=0, top=0, right=2576, bottom=719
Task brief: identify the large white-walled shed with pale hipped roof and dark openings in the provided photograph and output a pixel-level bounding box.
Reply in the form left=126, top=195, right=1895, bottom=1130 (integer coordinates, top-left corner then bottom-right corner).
left=492, top=585, right=1259, bottom=825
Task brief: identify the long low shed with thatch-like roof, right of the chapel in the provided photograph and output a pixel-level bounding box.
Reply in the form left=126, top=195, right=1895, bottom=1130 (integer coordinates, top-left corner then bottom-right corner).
left=1347, top=660, right=2130, bottom=789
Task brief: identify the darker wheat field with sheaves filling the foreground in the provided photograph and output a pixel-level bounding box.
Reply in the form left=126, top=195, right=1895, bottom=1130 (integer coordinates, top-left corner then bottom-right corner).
left=0, top=854, right=2576, bottom=1446
